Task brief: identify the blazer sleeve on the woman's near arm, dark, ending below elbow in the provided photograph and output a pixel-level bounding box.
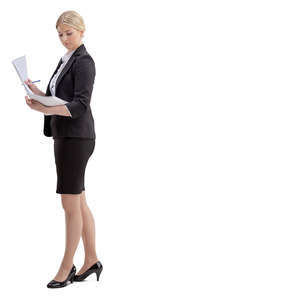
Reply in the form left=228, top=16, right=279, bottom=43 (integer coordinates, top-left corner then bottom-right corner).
left=65, top=55, right=96, bottom=119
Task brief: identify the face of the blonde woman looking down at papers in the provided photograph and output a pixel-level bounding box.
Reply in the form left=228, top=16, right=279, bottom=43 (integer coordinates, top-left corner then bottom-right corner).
left=57, top=24, right=83, bottom=51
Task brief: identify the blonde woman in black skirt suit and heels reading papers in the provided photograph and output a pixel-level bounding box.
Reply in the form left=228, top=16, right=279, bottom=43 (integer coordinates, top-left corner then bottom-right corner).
left=25, top=11, right=103, bottom=288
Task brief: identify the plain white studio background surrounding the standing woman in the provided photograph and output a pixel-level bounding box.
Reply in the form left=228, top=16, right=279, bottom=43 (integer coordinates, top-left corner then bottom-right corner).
left=0, top=0, right=300, bottom=300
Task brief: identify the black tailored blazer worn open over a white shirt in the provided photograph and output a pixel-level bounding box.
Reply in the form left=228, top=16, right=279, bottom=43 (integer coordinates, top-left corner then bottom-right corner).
left=44, top=44, right=96, bottom=139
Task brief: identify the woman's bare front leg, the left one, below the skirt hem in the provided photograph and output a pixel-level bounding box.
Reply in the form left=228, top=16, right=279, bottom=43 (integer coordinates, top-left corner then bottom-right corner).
left=54, top=194, right=83, bottom=281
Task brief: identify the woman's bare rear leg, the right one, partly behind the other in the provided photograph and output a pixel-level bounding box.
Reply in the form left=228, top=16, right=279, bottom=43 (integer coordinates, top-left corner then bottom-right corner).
left=76, top=191, right=99, bottom=275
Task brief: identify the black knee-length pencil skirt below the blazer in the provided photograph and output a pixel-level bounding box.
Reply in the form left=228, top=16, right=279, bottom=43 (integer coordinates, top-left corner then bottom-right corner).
left=53, top=137, right=95, bottom=194
